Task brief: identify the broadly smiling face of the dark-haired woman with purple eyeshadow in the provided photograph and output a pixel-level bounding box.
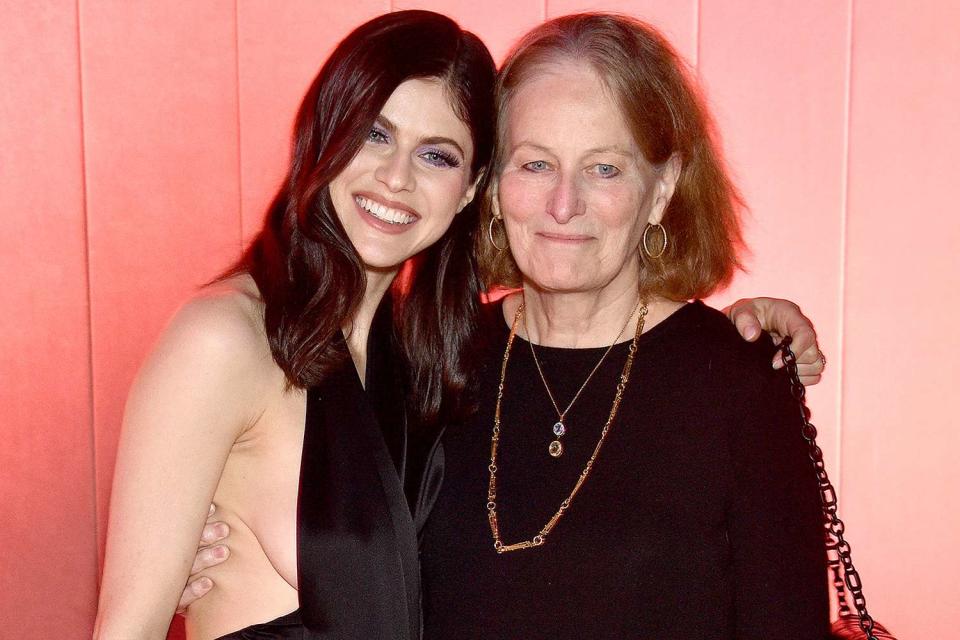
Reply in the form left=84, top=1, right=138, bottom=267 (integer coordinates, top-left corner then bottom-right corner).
left=330, top=79, right=475, bottom=270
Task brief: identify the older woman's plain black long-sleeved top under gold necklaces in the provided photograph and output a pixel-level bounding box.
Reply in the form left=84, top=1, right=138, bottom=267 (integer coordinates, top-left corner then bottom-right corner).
left=421, top=302, right=829, bottom=640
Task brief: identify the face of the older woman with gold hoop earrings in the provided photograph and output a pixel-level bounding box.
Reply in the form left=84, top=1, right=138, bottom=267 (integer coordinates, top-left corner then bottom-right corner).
left=494, top=63, right=679, bottom=292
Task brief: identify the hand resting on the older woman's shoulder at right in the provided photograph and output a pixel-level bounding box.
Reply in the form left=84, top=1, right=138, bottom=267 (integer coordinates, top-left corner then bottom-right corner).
left=724, top=298, right=827, bottom=386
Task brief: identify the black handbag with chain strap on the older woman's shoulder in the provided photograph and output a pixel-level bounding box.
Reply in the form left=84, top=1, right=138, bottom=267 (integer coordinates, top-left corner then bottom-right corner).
left=778, top=336, right=896, bottom=640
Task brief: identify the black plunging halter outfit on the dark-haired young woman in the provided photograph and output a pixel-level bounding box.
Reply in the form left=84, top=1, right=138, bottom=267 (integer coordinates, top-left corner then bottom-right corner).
left=220, top=297, right=436, bottom=640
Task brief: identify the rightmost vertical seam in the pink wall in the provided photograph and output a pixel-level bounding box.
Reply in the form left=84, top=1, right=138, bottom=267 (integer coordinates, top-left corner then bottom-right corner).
left=834, top=0, right=854, bottom=492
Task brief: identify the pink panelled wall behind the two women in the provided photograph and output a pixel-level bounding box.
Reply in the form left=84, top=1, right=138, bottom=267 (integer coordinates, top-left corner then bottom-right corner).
left=0, top=0, right=960, bottom=638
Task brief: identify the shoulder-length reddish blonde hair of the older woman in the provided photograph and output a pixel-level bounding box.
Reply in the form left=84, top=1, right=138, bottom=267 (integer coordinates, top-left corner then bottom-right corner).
left=477, top=13, right=743, bottom=300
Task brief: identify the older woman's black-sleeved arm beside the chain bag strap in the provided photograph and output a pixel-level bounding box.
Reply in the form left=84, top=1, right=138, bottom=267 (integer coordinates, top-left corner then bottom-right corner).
left=728, top=352, right=829, bottom=640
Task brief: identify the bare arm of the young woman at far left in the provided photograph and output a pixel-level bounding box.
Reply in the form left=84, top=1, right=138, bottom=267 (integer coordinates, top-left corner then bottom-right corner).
left=95, top=294, right=262, bottom=640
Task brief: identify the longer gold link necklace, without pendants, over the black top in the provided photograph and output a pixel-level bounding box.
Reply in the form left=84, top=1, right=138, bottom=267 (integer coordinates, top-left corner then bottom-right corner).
left=487, top=303, right=647, bottom=553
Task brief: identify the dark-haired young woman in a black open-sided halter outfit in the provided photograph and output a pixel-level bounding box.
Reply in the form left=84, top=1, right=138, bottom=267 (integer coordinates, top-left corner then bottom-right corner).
left=95, top=11, right=495, bottom=640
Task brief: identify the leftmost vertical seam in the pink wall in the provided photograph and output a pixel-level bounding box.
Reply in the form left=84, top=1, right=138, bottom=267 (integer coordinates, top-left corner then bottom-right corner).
left=74, top=0, right=103, bottom=592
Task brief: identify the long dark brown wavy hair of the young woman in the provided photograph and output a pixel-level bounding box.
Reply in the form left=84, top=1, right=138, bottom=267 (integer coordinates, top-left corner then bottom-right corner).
left=231, top=11, right=496, bottom=426
